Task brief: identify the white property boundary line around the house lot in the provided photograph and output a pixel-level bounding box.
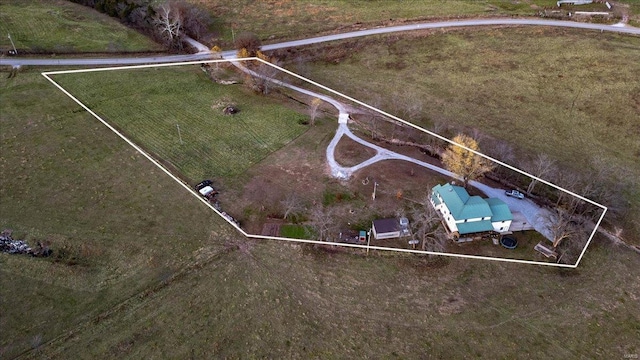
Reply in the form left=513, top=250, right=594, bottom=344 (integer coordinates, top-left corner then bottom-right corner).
left=41, top=57, right=607, bottom=269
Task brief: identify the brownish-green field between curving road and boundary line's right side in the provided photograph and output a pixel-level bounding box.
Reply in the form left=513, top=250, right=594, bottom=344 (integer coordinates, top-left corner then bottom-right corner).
left=292, top=28, right=640, bottom=243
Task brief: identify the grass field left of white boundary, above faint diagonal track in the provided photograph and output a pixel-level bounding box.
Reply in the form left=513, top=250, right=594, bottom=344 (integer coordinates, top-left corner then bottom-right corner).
left=0, top=71, right=235, bottom=358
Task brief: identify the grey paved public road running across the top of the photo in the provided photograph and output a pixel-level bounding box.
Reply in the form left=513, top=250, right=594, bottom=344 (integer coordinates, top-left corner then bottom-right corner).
left=0, top=18, right=640, bottom=66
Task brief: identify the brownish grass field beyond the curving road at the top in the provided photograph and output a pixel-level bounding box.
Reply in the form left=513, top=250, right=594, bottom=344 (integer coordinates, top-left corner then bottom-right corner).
left=189, top=0, right=640, bottom=42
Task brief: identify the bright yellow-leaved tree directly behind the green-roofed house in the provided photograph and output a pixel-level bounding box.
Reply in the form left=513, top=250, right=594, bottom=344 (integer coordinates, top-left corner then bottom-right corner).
left=442, top=134, right=494, bottom=188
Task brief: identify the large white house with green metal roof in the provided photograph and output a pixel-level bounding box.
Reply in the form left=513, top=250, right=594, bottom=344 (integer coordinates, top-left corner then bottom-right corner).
left=430, top=183, right=513, bottom=239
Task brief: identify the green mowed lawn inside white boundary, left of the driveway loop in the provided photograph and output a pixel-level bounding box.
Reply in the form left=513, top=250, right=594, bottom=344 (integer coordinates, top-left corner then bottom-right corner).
left=49, top=66, right=307, bottom=181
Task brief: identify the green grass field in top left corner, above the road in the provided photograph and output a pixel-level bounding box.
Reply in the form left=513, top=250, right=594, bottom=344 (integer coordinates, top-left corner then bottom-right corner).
left=0, top=0, right=162, bottom=55
